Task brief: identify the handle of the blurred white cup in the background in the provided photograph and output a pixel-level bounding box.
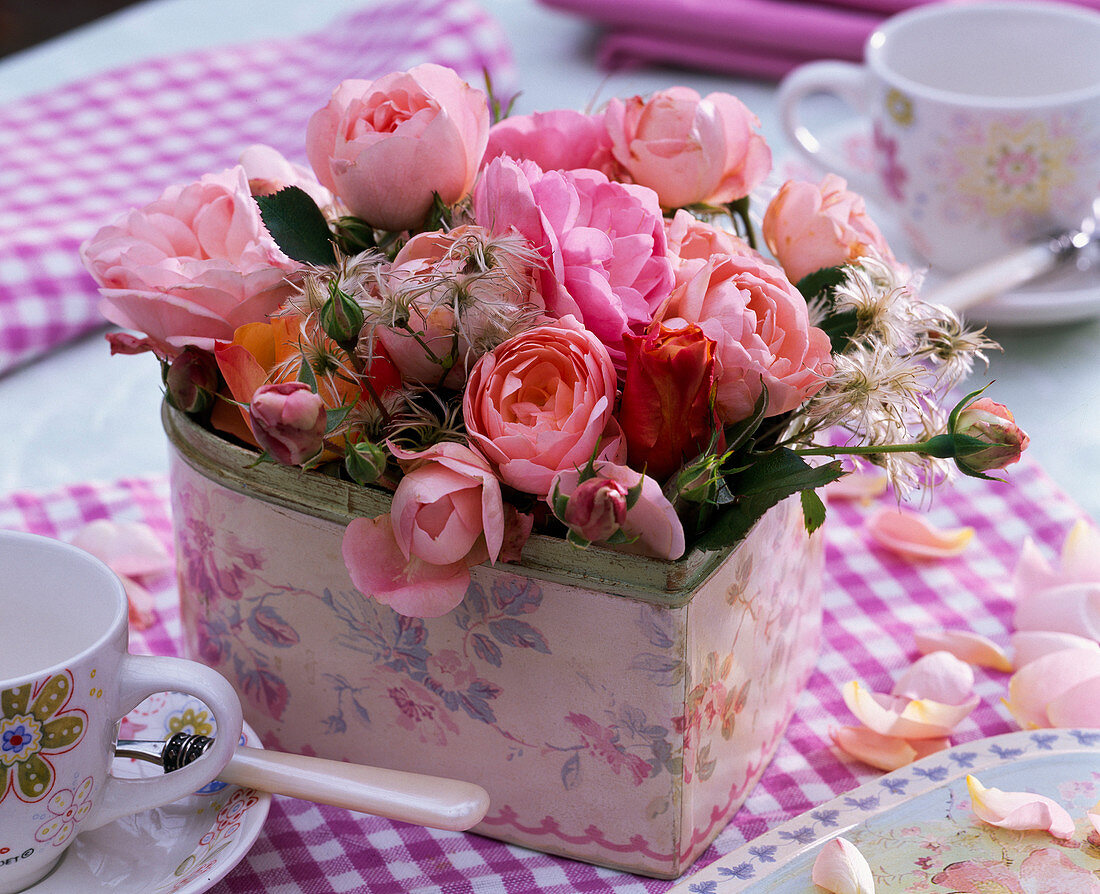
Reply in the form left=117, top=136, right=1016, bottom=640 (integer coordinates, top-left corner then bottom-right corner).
left=776, top=60, right=883, bottom=200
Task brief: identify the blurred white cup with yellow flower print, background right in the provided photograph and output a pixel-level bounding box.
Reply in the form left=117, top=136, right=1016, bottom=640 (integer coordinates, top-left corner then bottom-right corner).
left=778, top=0, right=1100, bottom=273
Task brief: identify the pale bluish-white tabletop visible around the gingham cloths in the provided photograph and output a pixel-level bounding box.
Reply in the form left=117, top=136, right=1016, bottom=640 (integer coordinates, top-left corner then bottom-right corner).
left=0, top=0, right=1100, bottom=519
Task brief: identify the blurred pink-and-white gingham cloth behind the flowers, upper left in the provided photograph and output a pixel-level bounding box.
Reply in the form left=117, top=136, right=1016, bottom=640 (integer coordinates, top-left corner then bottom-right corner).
left=0, top=0, right=513, bottom=374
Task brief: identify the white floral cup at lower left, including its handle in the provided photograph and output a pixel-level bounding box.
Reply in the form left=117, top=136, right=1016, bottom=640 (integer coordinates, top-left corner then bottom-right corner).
left=0, top=531, right=241, bottom=894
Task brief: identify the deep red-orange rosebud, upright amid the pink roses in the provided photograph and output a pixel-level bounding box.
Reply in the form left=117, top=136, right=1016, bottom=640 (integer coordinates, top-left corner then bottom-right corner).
left=619, top=324, right=719, bottom=482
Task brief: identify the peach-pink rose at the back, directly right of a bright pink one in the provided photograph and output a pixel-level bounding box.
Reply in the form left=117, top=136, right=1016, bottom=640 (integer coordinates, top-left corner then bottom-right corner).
left=604, top=87, right=771, bottom=208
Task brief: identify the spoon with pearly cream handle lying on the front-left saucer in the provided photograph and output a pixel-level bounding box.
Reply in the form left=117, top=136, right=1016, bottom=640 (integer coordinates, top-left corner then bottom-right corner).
left=114, top=732, right=488, bottom=831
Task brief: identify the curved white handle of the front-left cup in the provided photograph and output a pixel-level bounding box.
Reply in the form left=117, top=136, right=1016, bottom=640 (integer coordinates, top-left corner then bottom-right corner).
left=81, top=654, right=242, bottom=829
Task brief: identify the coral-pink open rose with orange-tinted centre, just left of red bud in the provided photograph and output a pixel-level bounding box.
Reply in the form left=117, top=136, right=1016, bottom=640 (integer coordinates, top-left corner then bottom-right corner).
left=462, top=318, right=623, bottom=497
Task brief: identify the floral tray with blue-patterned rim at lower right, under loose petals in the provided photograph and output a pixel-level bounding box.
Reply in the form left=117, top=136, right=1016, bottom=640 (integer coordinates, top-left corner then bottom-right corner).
left=667, top=729, right=1100, bottom=894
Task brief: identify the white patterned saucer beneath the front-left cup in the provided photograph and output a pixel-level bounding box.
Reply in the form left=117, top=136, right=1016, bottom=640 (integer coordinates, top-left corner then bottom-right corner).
left=29, top=693, right=271, bottom=894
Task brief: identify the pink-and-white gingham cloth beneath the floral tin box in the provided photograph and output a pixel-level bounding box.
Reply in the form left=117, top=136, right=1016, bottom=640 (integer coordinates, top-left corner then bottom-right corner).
left=0, top=460, right=1082, bottom=894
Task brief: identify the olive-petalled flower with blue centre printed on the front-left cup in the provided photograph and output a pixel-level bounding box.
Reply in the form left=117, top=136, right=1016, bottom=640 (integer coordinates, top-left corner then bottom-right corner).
left=0, top=671, right=88, bottom=802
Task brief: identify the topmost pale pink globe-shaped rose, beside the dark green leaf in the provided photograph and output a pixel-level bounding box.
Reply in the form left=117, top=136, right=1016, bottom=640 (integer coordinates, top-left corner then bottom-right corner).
left=306, top=63, right=490, bottom=230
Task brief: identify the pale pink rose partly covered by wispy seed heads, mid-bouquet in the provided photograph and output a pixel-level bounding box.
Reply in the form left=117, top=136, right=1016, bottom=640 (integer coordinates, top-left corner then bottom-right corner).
left=372, top=225, right=542, bottom=388
